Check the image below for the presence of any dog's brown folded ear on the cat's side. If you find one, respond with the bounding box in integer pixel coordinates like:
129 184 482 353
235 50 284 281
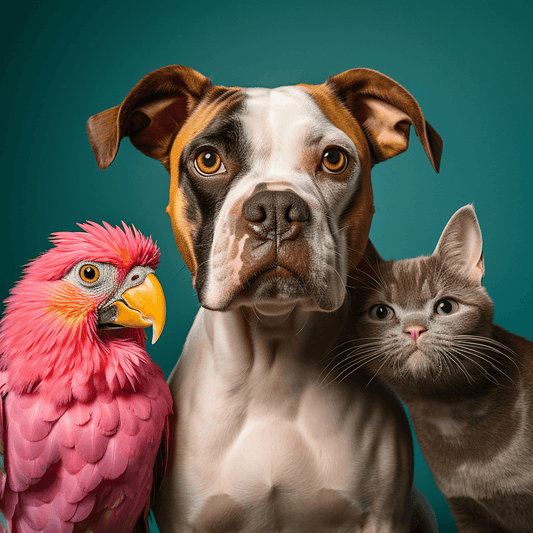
326 68 442 172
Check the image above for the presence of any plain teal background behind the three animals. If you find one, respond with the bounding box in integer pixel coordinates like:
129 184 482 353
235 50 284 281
0 0 533 533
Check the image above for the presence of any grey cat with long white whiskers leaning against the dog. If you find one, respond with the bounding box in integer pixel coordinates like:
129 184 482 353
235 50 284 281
340 205 533 533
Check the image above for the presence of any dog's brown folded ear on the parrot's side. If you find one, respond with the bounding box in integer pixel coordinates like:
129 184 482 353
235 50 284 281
87 65 212 170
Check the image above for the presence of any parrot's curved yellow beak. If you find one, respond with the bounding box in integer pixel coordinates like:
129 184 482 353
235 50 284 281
109 274 167 344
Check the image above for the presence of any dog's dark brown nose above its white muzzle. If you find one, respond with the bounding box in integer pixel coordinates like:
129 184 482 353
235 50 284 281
244 191 310 239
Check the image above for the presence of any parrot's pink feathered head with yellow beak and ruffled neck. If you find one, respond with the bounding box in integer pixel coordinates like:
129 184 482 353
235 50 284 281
0 222 166 400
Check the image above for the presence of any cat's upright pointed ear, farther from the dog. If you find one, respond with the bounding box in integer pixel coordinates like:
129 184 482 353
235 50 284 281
433 204 485 285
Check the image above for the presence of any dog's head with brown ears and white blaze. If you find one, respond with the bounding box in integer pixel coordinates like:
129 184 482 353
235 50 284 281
87 66 442 311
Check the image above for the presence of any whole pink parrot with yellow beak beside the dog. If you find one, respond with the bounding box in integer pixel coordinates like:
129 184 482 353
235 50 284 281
0 222 172 533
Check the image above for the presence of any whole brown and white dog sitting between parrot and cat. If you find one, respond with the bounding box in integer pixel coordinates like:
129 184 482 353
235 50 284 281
88 66 442 533
